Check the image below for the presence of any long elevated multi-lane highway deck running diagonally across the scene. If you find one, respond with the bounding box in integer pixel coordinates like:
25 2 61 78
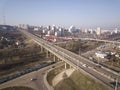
21 30 120 88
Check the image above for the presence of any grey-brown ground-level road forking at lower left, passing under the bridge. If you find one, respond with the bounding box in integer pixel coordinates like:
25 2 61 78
0 62 63 90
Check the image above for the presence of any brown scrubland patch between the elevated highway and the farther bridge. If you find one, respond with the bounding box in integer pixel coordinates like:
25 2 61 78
58 40 102 54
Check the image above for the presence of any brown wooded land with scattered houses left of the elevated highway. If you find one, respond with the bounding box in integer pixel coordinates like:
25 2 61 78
0 30 51 78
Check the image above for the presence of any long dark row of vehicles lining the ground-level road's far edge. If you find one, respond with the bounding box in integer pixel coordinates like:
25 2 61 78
0 61 54 84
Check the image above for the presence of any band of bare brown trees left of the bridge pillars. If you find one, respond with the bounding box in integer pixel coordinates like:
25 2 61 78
0 46 40 64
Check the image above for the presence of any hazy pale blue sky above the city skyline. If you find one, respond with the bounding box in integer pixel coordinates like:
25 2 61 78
0 0 120 28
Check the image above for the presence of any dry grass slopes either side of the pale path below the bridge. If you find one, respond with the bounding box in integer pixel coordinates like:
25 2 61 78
47 65 109 90
